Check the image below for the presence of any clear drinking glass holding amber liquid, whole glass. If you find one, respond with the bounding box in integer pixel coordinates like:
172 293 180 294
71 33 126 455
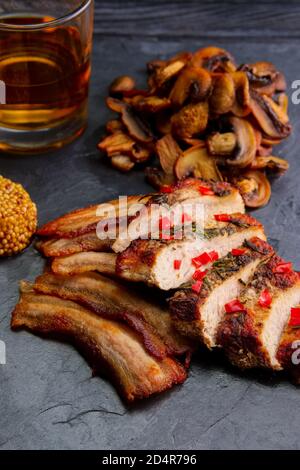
0 0 93 154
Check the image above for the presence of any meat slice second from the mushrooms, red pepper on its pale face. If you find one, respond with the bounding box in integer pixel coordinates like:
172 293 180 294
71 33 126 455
116 214 265 290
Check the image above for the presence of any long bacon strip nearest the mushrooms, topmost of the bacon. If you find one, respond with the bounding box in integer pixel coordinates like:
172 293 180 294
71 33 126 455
37 196 151 238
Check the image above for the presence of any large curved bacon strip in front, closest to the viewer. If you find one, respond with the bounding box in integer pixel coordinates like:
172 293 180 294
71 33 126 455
11 293 187 401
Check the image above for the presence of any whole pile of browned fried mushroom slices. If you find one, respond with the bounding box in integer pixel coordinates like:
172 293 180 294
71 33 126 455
98 47 291 208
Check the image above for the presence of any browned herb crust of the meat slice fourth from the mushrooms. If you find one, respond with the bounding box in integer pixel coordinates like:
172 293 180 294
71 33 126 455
218 255 298 369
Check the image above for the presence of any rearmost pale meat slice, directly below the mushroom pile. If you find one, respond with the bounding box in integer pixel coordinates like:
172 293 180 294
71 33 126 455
112 178 245 253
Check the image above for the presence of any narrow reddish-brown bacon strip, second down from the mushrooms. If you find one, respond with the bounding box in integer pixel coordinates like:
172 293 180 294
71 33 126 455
36 232 113 258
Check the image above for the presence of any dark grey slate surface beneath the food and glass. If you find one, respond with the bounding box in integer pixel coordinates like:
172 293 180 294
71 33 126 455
0 1 300 449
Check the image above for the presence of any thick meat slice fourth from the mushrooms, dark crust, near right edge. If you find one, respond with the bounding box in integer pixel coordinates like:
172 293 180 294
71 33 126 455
218 255 300 370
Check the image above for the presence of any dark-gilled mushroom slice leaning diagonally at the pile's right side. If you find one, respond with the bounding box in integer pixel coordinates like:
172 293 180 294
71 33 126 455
250 90 292 139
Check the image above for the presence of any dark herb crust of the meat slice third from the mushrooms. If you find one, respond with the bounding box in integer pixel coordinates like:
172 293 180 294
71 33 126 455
169 237 274 341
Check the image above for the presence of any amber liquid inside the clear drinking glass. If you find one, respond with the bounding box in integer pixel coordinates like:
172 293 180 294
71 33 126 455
0 16 90 143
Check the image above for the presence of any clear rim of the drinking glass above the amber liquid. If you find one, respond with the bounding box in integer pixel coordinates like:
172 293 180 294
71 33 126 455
0 0 93 31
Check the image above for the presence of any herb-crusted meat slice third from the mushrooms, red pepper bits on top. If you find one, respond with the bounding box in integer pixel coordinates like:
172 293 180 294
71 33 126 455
170 237 273 348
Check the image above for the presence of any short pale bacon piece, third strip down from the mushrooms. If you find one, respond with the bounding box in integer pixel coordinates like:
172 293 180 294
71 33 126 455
51 251 117 274
